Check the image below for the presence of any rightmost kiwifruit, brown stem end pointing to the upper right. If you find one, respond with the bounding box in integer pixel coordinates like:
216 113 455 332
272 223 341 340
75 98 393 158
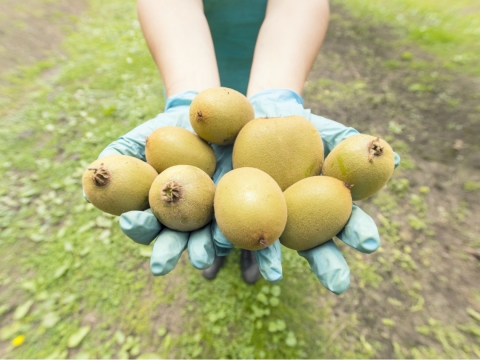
322 134 395 201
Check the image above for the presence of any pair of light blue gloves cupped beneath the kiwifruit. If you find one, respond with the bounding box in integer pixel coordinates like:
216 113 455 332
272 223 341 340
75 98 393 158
95 89 400 294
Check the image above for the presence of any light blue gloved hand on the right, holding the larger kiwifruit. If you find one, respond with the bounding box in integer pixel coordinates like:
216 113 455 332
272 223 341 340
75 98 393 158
213 89 400 294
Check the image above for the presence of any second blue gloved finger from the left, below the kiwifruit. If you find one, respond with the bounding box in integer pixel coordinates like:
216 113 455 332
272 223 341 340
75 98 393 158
150 228 190 276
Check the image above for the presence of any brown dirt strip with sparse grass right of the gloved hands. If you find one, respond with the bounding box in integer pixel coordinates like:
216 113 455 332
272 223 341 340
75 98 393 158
306 6 480 358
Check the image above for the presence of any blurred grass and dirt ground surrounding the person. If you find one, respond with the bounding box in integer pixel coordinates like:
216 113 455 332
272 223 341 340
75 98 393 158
0 0 480 358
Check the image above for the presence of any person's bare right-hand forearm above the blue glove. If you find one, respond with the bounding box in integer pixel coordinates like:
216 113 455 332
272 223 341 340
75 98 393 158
247 0 329 96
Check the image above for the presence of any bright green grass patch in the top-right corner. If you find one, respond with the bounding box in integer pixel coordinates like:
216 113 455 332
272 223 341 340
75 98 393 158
333 0 480 75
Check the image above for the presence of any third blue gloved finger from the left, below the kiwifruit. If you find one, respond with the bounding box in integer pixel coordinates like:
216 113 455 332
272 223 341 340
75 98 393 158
188 225 215 270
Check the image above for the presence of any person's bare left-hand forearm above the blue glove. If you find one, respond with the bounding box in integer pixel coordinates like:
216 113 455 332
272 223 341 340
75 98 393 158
137 0 220 96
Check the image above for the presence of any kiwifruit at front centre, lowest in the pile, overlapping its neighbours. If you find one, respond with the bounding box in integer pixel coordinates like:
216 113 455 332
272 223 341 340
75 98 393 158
215 167 287 250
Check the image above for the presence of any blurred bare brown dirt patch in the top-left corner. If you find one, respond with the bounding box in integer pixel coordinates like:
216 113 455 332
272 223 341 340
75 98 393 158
0 0 87 78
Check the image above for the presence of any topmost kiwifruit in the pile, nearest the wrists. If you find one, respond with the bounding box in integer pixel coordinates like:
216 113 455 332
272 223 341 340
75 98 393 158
190 87 255 145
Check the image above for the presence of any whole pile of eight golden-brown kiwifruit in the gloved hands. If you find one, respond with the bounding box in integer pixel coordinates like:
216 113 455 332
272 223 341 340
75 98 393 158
82 87 394 250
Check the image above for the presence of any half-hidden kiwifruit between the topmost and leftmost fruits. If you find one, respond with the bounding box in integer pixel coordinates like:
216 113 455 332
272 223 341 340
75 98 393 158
145 126 216 176
